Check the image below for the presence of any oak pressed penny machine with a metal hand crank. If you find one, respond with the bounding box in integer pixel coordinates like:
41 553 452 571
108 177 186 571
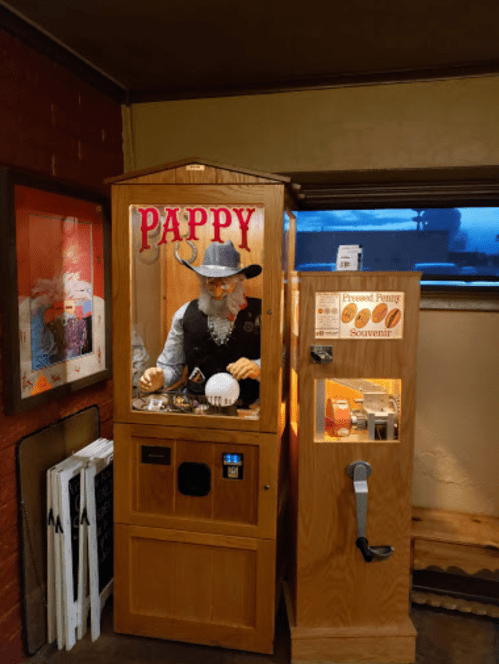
286 271 420 664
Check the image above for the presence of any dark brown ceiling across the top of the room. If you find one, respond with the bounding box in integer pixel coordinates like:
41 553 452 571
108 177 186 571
0 0 499 101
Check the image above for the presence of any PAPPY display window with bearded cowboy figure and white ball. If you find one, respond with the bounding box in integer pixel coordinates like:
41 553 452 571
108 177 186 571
129 205 264 419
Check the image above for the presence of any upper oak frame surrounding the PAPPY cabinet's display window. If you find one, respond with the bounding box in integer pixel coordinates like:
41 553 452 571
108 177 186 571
113 178 285 433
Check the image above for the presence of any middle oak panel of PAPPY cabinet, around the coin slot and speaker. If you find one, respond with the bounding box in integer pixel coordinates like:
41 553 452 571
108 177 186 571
114 425 280 539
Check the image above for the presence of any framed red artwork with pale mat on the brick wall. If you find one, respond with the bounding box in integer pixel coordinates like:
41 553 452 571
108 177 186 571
0 168 111 414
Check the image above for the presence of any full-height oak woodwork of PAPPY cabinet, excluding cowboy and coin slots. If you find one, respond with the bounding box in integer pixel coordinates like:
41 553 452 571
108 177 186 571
112 169 289 653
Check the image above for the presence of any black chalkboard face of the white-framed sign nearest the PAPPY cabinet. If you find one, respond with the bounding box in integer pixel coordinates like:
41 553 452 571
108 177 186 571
95 462 113 593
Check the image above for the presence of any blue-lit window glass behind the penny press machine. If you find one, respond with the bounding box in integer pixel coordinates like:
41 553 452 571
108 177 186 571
296 207 499 288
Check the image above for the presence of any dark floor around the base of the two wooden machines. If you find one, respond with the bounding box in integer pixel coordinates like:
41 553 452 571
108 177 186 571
26 603 499 664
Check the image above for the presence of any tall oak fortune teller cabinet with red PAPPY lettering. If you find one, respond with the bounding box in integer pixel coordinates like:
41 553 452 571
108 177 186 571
111 161 292 653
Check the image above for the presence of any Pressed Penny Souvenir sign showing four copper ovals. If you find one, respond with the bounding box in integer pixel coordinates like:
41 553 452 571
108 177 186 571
315 291 405 340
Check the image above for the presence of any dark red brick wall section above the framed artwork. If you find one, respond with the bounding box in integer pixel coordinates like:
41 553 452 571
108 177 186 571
0 26 123 189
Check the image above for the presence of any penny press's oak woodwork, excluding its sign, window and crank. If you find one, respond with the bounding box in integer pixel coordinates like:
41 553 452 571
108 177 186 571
289 273 419 662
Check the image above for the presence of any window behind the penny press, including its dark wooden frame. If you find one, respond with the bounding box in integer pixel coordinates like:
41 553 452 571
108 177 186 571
285 166 499 294
